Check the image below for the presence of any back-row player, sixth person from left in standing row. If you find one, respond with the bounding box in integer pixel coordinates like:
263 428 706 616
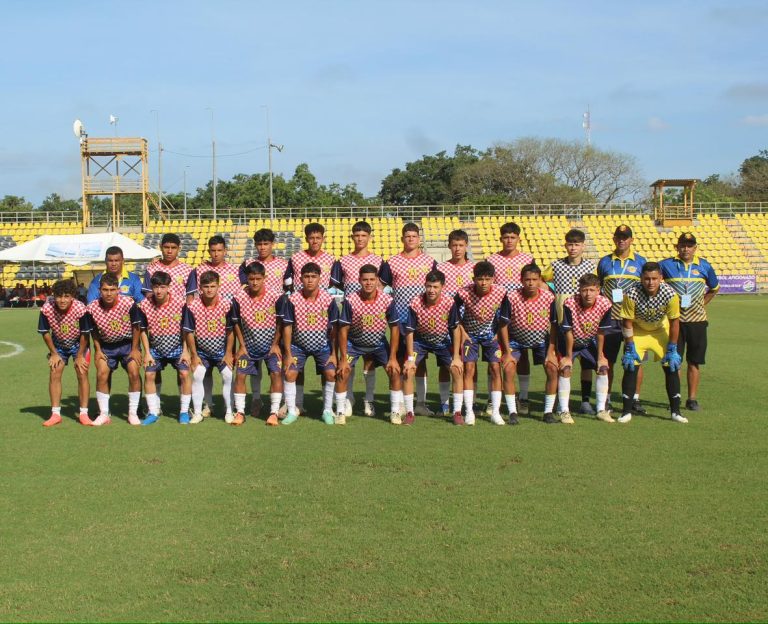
331 221 383 418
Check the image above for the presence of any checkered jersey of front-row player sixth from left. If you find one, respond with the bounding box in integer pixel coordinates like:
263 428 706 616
283 290 339 353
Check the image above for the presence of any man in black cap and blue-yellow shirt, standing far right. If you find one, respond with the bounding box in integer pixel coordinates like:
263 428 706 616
661 232 720 412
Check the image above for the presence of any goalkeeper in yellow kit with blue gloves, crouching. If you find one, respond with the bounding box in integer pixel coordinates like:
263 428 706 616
618 262 688 423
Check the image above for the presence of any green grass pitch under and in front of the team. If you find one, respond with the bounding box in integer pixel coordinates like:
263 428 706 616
0 297 768 621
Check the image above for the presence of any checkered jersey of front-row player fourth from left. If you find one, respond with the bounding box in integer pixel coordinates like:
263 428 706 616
181 296 237 361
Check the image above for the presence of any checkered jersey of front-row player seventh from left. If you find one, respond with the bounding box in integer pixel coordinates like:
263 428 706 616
339 290 400 348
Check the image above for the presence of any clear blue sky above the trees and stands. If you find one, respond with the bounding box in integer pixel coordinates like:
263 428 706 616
0 0 768 204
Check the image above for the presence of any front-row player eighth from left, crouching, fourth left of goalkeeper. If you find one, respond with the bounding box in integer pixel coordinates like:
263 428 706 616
400 269 462 425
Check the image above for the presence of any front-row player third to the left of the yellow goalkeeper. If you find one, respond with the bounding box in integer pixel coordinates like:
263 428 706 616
453 261 514 425
